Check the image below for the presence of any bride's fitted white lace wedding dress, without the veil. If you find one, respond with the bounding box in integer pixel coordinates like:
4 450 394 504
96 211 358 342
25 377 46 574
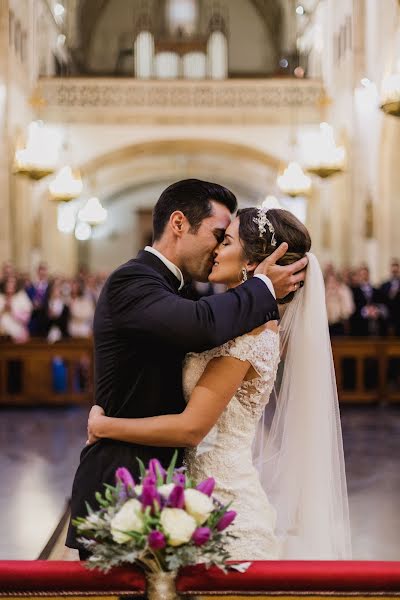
183 329 280 560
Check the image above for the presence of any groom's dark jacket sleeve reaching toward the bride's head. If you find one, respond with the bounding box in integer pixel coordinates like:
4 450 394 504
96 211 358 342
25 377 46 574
108 267 279 352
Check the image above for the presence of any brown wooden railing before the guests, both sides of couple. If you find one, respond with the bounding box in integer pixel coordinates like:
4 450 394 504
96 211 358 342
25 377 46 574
0 338 400 405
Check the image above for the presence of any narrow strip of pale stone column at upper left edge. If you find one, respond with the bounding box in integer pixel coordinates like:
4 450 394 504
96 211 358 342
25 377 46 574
0 0 14 262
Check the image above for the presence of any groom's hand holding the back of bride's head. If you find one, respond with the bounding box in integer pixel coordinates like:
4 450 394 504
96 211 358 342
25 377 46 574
254 242 308 298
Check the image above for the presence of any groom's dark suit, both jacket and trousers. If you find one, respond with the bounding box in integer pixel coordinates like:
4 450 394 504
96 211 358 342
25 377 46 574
67 251 279 548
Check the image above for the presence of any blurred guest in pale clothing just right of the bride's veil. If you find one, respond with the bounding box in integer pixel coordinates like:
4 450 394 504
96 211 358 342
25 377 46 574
325 271 355 336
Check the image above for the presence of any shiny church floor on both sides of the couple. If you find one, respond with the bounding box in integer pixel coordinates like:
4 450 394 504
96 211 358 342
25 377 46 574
0 406 400 560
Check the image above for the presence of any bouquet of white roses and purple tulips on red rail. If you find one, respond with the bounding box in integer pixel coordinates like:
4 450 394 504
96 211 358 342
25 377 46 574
74 453 236 574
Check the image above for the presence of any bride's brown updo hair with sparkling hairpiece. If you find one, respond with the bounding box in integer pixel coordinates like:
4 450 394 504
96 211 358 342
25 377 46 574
237 208 311 304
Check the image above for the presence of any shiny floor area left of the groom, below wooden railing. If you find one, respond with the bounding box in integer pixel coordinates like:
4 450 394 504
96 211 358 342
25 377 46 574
0 407 88 559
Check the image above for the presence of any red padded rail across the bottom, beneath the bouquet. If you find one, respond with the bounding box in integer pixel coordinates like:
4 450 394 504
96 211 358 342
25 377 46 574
0 561 400 597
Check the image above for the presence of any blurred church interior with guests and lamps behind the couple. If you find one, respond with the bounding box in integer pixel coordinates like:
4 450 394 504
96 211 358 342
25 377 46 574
0 0 400 595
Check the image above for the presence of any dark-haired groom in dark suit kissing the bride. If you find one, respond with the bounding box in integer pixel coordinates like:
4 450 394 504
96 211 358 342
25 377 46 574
66 179 307 558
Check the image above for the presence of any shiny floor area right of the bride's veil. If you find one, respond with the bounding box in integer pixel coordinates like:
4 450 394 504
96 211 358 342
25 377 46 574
341 405 400 560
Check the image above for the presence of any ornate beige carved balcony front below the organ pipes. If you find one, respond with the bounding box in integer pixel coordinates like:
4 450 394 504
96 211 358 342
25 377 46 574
40 78 325 124
